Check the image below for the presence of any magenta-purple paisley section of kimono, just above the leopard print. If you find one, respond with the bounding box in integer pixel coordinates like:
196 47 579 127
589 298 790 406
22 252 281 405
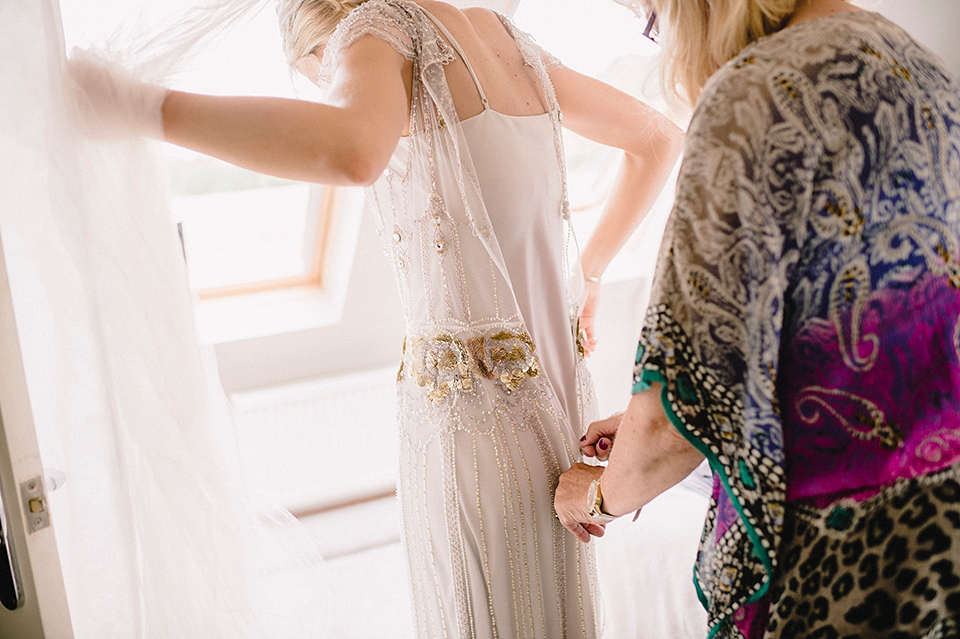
780 273 960 503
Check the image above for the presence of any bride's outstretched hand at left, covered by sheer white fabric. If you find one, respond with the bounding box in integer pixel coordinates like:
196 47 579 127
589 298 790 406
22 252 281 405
66 48 169 139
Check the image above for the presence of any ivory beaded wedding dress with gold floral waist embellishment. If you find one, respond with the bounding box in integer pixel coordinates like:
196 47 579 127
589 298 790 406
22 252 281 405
324 0 597 639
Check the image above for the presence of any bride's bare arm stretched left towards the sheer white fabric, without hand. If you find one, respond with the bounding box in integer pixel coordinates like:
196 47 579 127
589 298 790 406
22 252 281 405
163 36 410 185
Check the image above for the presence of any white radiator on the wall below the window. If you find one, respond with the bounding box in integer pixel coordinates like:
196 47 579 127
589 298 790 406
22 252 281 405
230 367 398 512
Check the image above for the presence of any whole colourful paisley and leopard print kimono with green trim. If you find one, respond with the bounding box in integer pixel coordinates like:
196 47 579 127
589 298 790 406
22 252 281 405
635 12 960 638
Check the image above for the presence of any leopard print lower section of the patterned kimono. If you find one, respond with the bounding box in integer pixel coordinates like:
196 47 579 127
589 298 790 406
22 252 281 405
766 467 960 639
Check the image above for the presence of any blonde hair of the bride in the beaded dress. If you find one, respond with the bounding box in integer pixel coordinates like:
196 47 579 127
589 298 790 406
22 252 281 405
277 0 367 65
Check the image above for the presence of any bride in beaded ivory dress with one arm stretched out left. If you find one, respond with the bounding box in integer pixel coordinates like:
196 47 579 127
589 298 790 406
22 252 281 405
71 0 681 638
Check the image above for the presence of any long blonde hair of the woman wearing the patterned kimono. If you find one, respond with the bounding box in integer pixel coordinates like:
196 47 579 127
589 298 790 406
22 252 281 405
653 0 803 104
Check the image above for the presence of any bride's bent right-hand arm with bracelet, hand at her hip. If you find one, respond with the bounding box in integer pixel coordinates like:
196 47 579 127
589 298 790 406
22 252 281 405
550 66 683 351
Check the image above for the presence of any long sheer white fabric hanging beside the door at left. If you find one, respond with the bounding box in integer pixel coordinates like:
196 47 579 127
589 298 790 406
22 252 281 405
0 0 330 639
